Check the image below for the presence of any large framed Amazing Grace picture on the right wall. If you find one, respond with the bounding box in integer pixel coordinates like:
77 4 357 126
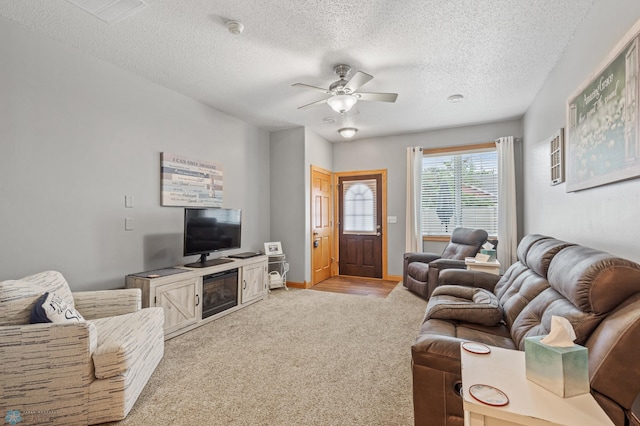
565 21 640 192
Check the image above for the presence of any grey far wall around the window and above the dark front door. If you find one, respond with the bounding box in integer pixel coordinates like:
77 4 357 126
333 120 522 275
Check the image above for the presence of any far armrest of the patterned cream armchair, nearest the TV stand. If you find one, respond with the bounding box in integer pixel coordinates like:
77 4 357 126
73 288 142 319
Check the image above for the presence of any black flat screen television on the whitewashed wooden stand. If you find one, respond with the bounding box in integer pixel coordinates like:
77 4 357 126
184 208 242 268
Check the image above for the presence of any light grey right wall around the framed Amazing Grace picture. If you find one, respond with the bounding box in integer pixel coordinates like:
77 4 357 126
524 0 640 261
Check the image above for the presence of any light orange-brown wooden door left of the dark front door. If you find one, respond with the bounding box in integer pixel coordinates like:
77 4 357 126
311 166 333 284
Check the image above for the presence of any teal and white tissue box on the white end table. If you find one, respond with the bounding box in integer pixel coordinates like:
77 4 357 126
524 336 590 398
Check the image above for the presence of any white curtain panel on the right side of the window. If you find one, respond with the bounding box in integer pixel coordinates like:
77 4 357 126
496 136 518 271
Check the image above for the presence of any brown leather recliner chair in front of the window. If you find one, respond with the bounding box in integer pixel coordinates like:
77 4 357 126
402 228 488 299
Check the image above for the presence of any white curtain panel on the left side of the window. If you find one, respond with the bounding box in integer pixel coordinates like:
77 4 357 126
405 147 422 252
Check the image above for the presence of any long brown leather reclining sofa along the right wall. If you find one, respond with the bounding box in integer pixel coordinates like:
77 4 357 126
411 235 640 426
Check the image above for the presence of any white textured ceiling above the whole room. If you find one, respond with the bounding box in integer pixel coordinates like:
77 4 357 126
0 0 605 141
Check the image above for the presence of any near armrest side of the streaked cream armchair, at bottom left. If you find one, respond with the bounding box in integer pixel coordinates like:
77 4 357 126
0 322 97 424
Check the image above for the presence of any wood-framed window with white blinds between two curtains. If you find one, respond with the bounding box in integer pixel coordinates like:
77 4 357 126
421 143 498 237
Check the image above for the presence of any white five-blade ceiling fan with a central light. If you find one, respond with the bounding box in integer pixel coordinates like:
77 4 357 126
293 64 398 113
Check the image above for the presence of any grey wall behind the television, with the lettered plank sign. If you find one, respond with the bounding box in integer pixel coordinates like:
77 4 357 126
0 19 269 290
